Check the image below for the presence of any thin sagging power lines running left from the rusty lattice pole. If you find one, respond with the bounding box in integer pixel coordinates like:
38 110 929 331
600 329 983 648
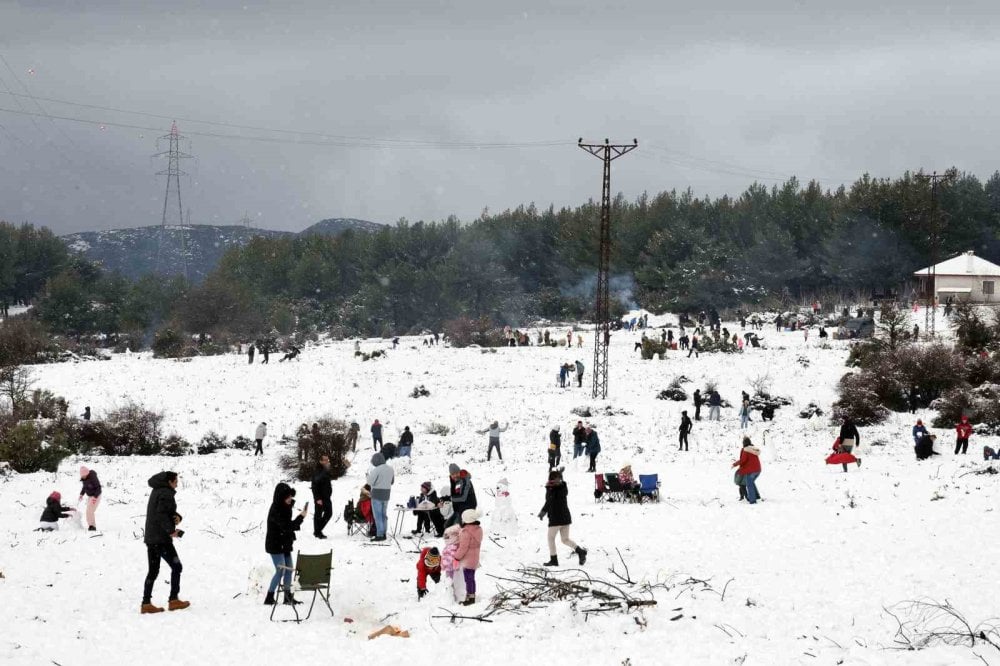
0 90 572 148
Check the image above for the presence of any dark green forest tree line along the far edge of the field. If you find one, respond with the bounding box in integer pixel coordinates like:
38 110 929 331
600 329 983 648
0 166 1000 343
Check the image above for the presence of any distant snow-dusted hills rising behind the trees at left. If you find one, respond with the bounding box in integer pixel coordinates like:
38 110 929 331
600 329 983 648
62 218 382 282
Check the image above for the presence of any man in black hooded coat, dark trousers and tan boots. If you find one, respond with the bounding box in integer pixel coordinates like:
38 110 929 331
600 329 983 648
139 472 191 614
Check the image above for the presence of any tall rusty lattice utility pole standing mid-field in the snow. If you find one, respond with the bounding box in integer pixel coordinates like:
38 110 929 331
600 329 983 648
577 139 639 399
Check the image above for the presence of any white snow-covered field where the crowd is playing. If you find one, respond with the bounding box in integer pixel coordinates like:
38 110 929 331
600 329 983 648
0 308 1000 666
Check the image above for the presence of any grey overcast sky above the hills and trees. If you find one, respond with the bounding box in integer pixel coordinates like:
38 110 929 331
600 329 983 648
0 0 1000 233
